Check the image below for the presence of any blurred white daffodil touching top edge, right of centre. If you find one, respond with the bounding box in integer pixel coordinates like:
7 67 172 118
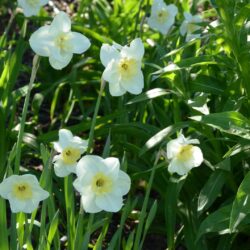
148 0 178 35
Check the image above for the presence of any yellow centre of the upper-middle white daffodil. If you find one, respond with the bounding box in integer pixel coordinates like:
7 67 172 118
119 57 138 78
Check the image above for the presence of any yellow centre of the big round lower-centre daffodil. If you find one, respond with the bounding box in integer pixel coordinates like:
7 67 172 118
91 173 113 195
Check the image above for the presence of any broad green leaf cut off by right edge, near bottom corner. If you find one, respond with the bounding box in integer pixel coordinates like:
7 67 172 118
230 172 250 232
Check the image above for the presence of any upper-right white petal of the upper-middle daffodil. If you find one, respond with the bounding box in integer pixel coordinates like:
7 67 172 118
121 38 144 61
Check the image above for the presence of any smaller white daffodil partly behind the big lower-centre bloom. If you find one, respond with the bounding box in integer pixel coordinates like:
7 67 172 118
53 129 88 177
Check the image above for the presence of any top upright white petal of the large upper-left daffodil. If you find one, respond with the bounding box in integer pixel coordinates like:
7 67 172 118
50 11 71 33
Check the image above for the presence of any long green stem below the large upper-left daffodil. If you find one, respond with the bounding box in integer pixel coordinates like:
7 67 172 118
14 55 39 174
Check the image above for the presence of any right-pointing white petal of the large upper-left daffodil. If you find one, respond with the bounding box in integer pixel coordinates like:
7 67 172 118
69 32 90 54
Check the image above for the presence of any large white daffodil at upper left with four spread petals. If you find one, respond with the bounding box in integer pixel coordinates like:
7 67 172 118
29 11 90 69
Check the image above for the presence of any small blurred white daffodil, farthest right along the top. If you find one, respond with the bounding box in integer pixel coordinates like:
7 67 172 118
180 12 202 42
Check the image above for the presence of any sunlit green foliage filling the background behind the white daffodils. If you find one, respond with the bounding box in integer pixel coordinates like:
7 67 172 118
0 0 250 250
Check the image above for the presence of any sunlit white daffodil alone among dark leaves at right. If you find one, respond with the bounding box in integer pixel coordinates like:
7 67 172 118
167 134 203 175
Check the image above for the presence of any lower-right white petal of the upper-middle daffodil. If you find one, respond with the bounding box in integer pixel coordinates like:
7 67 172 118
120 70 144 95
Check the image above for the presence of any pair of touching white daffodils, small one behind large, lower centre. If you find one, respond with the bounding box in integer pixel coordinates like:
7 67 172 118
54 129 130 213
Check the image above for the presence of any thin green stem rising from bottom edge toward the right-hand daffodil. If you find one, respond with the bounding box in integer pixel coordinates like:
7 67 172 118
133 153 160 250
